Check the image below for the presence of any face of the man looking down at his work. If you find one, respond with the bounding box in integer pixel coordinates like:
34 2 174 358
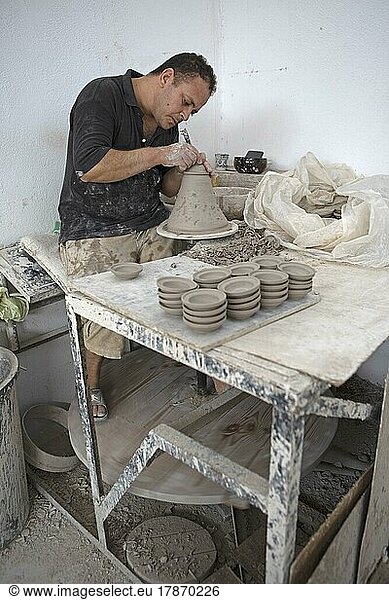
154 69 210 129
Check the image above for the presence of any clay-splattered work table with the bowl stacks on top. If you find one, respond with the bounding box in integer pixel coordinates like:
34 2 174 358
62 252 389 583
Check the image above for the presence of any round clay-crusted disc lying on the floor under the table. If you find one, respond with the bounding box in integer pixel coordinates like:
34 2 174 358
125 515 216 583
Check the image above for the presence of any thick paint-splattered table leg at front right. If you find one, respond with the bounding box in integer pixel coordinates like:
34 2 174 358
265 406 305 583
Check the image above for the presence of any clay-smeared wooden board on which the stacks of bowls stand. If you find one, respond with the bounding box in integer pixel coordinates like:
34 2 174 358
69 256 320 351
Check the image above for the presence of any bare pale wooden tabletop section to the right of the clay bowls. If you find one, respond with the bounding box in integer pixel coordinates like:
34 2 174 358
223 263 389 385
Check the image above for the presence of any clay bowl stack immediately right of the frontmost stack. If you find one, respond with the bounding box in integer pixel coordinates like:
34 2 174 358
217 271 261 320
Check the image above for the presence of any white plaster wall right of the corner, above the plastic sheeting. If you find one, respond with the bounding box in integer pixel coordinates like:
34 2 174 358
219 0 389 175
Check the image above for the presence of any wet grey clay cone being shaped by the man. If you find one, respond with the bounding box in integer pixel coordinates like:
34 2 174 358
165 165 230 235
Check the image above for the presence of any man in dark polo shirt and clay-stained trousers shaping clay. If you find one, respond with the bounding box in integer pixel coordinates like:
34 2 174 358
59 52 216 419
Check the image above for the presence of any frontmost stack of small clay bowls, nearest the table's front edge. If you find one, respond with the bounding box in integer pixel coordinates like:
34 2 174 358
181 288 227 333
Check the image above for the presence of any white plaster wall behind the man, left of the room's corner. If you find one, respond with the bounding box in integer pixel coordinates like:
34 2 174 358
0 0 220 245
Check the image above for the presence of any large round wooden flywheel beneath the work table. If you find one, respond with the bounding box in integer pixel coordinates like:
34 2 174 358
69 348 337 505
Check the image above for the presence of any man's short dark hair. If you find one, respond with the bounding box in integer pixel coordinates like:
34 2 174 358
149 52 216 96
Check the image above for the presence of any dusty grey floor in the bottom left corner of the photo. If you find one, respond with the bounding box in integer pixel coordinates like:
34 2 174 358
0 490 389 584
